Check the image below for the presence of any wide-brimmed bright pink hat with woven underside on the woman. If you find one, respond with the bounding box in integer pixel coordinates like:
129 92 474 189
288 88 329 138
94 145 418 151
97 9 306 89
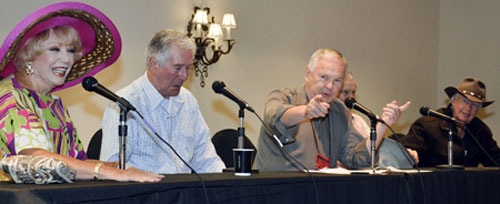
0 2 122 91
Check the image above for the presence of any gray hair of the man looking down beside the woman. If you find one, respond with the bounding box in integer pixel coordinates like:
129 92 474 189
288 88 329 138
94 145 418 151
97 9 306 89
146 29 196 69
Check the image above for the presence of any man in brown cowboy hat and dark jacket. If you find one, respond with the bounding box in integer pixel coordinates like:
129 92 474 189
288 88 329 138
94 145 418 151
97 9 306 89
402 77 500 167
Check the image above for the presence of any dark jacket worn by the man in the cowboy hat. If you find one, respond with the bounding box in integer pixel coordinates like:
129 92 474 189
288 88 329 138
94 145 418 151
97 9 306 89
401 105 500 167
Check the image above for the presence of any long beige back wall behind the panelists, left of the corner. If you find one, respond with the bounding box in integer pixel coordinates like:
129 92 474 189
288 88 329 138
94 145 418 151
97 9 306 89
0 0 498 151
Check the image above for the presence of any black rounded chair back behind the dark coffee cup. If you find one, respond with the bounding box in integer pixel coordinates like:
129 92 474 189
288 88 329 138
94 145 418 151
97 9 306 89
212 129 257 168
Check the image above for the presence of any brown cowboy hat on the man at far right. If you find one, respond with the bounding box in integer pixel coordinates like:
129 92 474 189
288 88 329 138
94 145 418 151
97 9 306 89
444 77 495 108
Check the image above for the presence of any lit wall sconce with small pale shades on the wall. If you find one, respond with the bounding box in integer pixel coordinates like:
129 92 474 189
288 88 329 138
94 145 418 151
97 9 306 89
187 7 237 87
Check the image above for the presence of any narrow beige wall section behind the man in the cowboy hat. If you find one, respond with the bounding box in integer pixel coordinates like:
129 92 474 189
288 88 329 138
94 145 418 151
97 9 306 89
436 0 500 141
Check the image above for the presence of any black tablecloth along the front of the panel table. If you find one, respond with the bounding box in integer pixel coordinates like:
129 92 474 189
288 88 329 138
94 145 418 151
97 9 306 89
0 169 500 204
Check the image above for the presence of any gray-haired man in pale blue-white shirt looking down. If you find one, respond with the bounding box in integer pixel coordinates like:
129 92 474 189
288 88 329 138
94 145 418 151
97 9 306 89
100 30 225 174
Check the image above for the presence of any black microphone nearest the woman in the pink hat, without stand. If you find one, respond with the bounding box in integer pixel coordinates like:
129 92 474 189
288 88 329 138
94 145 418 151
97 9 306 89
82 77 135 111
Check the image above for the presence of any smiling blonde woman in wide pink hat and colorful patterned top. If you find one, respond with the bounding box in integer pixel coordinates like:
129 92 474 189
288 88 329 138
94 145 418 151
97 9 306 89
0 2 163 182
